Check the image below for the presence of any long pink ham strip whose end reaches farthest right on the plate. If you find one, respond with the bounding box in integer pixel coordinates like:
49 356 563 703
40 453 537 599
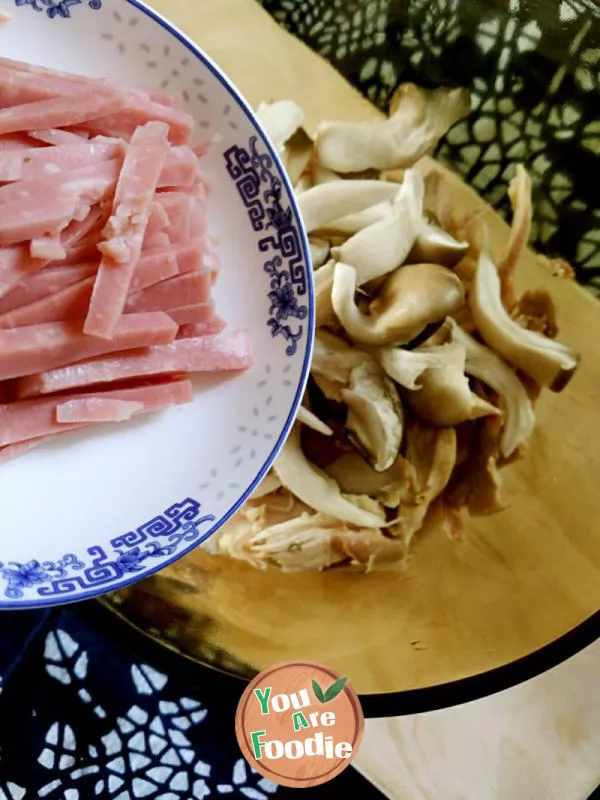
15 331 253 398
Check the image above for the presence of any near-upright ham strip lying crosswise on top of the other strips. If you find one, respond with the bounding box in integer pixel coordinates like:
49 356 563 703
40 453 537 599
84 122 168 338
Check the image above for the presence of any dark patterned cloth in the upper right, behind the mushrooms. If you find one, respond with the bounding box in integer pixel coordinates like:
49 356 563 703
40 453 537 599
259 0 600 296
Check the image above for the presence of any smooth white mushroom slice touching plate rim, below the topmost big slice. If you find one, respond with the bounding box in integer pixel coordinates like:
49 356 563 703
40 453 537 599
298 180 398 233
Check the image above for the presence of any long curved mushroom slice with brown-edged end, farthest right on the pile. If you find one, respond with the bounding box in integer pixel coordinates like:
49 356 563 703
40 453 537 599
468 251 579 392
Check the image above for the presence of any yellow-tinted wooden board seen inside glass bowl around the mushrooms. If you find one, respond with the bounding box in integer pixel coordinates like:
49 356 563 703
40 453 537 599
136 0 600 692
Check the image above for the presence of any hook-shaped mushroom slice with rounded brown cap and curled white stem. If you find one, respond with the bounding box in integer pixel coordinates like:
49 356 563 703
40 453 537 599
331 262 464 346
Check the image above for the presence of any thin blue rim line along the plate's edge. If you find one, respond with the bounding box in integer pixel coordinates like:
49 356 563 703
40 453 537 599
0 0 315 611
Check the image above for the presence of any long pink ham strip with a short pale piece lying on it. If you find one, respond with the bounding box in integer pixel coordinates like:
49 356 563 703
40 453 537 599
0 380 192 446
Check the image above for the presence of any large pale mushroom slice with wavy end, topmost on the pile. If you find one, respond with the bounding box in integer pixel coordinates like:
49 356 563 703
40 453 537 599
316 84 470 174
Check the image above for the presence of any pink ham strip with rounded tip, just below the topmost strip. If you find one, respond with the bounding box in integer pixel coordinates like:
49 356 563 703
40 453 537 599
0 89 127 133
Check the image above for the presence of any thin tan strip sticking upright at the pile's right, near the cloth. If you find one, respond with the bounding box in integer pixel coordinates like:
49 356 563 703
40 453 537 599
498 164 533 311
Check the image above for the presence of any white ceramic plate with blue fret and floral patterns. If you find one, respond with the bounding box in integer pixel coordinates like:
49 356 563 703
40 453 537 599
0 0 313 608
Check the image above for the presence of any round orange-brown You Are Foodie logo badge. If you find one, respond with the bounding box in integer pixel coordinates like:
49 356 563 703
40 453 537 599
235 661 365 789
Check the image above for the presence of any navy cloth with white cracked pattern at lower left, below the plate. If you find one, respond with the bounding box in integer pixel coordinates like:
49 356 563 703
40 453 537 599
0 603 383 800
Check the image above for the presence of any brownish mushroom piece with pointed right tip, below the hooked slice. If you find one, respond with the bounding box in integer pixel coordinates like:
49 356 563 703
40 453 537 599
404 343 500 426
